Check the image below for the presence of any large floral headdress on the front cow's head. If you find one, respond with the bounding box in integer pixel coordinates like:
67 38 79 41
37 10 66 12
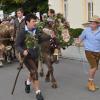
37 14 74 48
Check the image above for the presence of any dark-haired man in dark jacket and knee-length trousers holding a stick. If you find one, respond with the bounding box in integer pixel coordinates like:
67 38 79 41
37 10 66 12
16 14 44 100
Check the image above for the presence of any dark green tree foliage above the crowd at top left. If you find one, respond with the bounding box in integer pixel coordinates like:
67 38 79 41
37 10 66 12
0 0 48 13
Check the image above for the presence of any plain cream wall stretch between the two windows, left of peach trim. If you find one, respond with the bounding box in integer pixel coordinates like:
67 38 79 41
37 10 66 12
68 0 84 28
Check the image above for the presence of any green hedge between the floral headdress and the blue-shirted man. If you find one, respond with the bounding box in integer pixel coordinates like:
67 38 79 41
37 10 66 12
69 28 83 38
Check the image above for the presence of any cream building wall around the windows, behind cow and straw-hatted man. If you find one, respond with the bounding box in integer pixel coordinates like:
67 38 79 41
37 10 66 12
49 0 100 28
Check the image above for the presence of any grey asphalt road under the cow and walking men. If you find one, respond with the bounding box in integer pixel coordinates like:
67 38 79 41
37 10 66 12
0 59 100 100
